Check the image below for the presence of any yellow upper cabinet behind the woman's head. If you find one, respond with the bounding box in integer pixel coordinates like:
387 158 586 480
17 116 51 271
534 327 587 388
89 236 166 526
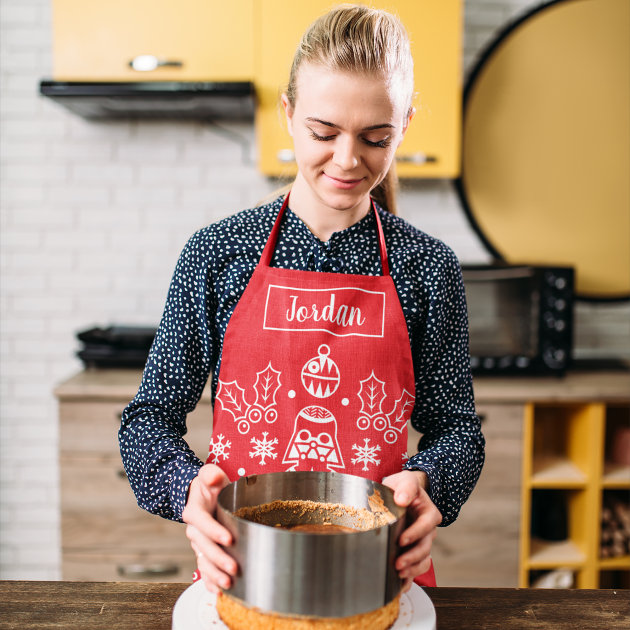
255 0 463 178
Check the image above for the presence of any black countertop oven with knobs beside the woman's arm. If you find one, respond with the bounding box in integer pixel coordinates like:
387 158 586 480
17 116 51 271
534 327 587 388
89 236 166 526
462 265 574 374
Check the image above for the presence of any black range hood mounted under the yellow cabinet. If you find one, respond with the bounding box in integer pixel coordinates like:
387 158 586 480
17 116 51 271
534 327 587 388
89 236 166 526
39 80 255 120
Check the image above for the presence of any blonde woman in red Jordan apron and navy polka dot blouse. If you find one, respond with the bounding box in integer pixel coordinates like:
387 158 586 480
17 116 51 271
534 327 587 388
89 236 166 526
120 5 484 592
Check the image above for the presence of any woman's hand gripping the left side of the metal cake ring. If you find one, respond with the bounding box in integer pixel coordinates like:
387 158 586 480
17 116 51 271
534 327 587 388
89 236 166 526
182 464 238 593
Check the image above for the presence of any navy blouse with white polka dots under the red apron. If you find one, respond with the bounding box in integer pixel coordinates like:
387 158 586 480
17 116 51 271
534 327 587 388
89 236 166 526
119 198 484 525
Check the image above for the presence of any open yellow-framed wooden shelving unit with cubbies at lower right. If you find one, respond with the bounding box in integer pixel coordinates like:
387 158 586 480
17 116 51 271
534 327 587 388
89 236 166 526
519 397 630 588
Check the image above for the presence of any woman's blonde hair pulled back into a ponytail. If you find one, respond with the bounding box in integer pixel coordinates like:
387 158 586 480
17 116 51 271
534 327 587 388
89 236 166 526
286 4 413 214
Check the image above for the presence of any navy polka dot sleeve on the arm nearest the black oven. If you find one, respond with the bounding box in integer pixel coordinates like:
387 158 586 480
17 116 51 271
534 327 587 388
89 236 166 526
405 247 485 526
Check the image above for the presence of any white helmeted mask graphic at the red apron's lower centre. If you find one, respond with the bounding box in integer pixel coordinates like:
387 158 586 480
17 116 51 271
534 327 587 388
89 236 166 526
282 405 345 471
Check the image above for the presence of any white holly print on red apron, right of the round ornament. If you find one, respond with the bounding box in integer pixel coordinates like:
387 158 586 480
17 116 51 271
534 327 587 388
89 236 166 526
357 371 415 444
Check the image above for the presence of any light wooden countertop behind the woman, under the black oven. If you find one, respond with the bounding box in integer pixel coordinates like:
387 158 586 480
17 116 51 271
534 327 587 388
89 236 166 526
55 369 630 404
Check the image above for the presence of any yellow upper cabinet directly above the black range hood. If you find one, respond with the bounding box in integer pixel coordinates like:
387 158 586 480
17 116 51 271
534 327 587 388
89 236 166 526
52 0 254 81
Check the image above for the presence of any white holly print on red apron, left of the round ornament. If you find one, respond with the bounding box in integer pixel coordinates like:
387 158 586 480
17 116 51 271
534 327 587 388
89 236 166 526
216 362 280 435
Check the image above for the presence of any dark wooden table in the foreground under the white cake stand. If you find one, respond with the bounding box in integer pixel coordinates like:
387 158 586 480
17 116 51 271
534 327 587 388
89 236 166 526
0 581 630 630
